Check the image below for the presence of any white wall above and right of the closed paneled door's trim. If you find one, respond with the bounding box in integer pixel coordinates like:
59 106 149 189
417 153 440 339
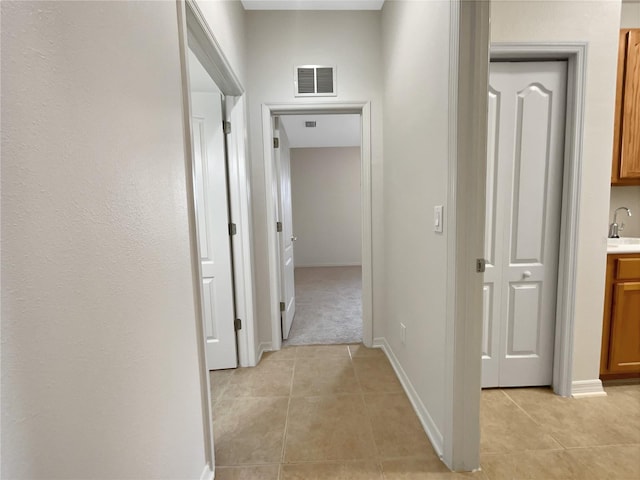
491 0 620 381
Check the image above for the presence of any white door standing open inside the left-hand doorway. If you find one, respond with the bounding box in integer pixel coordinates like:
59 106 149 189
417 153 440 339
189 50 238 370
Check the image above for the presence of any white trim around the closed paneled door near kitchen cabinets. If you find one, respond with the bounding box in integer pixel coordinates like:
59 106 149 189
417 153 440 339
491 42 587 397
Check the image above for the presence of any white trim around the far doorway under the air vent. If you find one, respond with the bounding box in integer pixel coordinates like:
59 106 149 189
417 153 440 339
262 102 373 350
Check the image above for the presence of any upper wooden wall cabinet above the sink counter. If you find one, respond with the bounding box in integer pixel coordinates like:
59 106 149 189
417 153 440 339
611 28 640 185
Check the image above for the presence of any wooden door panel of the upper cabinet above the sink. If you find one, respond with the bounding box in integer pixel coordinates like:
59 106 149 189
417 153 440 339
620 29 640 179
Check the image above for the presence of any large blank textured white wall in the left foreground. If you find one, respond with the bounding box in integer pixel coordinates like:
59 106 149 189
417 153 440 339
1 2 216 479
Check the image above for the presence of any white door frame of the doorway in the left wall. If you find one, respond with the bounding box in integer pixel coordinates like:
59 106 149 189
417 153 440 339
176 0 256 472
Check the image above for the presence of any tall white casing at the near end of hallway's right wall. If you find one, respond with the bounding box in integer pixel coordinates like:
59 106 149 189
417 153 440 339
442 0 490 471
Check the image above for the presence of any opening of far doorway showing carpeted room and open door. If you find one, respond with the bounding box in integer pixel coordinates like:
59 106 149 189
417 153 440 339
274 114 362 346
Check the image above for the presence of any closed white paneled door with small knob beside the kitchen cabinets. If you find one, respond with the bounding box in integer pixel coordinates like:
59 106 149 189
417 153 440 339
482 61 567 388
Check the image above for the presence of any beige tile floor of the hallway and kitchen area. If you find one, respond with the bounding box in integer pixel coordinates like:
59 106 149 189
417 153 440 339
211 345 640 480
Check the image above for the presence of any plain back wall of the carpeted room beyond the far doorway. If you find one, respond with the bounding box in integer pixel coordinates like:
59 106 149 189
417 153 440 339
291 147 362 267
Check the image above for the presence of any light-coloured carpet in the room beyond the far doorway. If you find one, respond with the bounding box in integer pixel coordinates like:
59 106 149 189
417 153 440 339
284 267 362 345
